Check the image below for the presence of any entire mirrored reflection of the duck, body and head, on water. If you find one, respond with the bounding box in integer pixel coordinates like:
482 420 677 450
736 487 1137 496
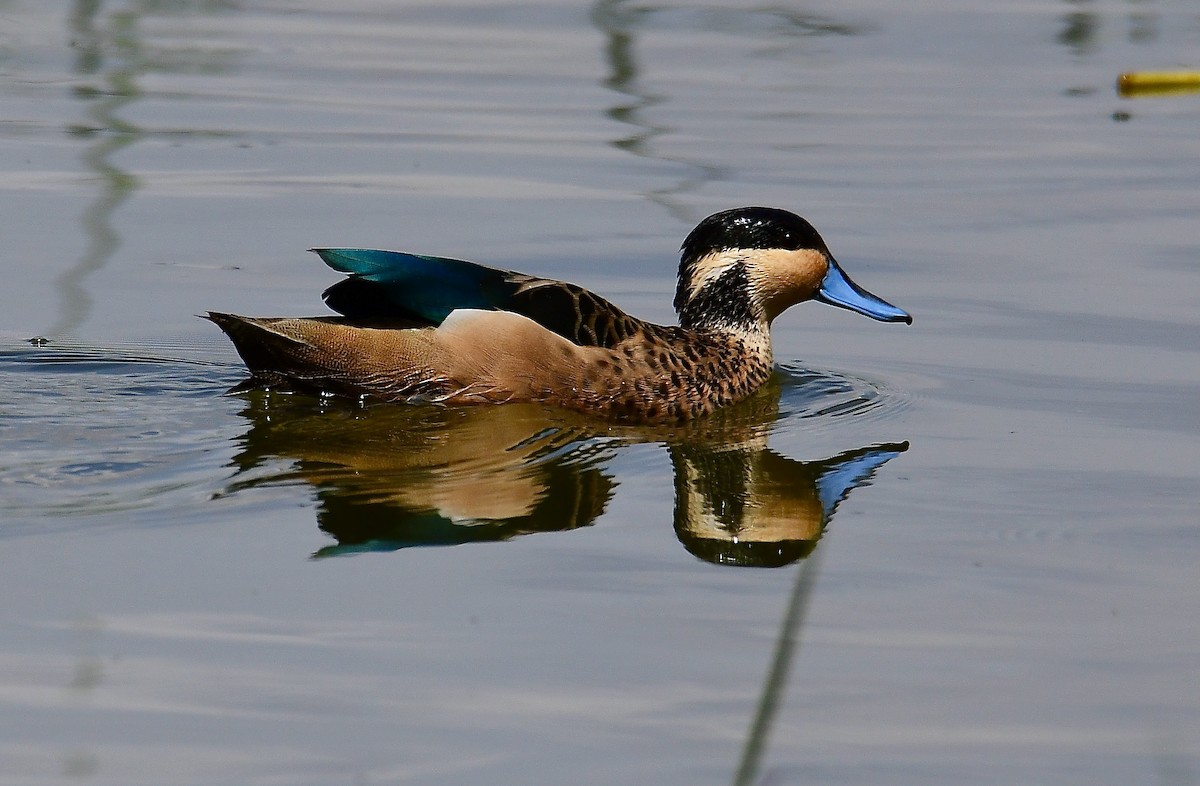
230 384 907 566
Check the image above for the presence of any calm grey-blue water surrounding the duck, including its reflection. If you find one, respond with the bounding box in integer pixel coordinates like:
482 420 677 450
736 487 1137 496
0 0 1200 785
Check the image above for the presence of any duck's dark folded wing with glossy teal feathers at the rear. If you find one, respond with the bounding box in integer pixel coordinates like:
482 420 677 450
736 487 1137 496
313 248 641 347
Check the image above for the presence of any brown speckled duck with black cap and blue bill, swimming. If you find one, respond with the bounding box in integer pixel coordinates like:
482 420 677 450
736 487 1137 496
208 208 912 421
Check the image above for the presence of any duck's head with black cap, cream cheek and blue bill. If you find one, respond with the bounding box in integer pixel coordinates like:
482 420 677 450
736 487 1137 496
674 208 912 329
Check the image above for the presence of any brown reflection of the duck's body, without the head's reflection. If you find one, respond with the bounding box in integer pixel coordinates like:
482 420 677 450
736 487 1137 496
234 400 614 557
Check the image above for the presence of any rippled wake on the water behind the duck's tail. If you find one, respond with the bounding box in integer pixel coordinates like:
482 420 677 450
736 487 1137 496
0 346 239 534
